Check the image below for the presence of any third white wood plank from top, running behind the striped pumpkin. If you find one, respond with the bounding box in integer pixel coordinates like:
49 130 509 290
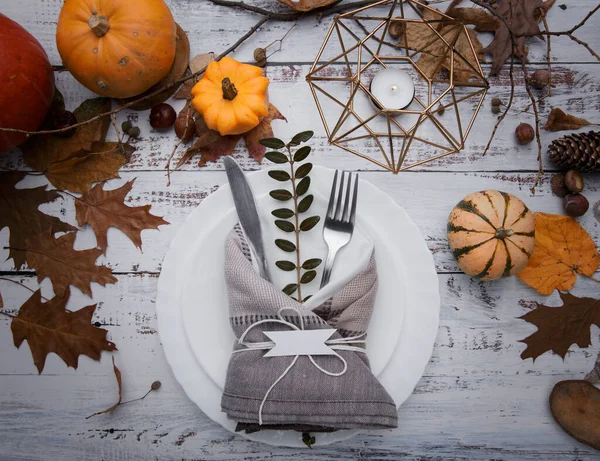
0 171 600 272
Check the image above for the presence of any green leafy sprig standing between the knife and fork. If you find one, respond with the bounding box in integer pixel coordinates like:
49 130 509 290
259 131 322 302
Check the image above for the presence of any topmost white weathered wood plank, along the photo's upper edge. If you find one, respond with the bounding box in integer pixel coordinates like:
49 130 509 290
2 0 600 64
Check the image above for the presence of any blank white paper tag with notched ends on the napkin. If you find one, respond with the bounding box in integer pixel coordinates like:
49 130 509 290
263 329 336 357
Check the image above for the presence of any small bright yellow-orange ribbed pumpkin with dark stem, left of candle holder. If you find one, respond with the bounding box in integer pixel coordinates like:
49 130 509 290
192 56 269 136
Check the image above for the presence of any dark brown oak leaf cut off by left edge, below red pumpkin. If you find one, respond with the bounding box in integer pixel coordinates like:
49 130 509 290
0 172 76 270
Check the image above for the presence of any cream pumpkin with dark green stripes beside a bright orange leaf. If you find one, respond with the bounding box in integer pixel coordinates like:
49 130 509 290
448 190 535 280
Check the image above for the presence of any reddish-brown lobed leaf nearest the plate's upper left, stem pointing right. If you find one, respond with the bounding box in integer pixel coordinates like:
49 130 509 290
75 179 169 253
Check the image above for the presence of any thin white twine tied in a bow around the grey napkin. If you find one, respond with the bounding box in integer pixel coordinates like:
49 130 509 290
233 306 366 426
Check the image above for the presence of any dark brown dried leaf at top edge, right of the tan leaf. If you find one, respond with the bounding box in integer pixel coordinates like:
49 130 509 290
483 0 555 76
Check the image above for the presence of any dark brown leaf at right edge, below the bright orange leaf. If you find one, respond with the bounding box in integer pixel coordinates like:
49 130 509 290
520 292 600 361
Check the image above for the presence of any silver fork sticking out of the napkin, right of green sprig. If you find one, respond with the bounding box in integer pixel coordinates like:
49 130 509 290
321 170 358 288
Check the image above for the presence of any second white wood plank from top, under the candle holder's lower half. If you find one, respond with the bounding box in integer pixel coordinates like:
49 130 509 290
0 64 600 171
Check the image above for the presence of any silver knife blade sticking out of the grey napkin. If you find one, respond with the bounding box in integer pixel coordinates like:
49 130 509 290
223 157 271 280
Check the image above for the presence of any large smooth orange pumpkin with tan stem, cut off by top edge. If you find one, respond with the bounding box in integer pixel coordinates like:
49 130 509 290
56 0 176 98
